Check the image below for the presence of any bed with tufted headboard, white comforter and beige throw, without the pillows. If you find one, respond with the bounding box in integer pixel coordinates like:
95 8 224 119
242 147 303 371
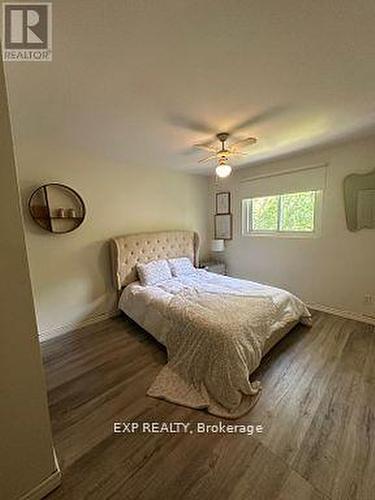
110 231 311 418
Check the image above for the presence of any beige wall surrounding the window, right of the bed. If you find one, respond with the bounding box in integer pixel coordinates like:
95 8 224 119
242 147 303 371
210 137 375 317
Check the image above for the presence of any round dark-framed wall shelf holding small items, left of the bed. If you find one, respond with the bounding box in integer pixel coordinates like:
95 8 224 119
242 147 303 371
29 182 86 234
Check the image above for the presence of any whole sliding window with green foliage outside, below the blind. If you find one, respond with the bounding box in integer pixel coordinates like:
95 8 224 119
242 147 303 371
243 191 321 236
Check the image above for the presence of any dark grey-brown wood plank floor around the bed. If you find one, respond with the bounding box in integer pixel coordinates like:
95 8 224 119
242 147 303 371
42 313 375 500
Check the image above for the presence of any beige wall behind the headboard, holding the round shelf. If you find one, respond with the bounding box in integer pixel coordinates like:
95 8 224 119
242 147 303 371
14 152 208 334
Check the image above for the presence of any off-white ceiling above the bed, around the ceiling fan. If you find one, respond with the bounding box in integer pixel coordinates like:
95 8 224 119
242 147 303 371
7 0 375 172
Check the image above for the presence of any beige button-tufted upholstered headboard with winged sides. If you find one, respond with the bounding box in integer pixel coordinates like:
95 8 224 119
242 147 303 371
110 231 199 290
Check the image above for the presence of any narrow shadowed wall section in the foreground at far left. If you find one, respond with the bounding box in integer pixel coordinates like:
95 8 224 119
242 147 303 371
0 57 55 500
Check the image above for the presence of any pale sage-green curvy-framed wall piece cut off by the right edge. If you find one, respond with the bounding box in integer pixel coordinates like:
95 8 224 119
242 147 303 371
344 170 375 231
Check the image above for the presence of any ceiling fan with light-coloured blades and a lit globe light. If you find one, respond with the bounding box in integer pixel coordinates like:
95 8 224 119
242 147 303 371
194 132 257 177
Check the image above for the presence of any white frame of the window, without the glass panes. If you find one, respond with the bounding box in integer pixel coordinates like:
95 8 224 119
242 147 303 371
242 189 323 238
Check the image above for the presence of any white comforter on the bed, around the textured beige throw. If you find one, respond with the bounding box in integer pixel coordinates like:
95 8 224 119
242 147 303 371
119 269 308 354
